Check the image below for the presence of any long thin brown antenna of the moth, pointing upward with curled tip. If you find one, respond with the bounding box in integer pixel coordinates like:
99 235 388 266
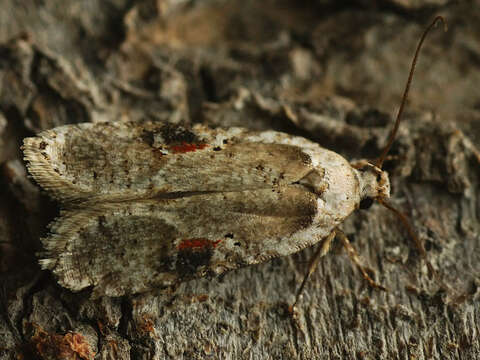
375 15 447 169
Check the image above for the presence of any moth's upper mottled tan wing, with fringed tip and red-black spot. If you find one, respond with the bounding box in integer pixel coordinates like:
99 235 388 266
24 122 312 206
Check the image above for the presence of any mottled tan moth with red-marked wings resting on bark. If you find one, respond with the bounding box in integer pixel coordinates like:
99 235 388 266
23 18 443 298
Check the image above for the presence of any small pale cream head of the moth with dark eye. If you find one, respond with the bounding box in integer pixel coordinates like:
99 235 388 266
352 160 390 209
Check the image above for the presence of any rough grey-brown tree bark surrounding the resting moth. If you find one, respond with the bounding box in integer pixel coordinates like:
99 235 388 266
0 0 480 359
